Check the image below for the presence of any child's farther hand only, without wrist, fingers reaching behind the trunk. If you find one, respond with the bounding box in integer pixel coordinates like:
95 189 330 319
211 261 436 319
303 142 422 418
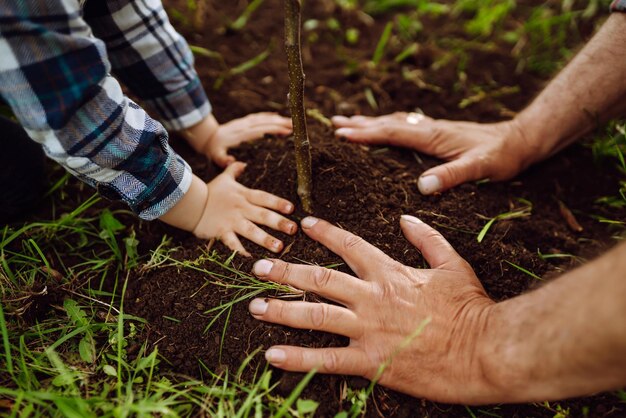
202 113 293 167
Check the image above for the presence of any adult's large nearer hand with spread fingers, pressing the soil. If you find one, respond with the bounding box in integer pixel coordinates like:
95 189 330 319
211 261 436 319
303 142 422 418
249 216 495 404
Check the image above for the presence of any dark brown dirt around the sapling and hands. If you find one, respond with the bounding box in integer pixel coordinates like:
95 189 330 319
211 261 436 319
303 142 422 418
126 0 626 417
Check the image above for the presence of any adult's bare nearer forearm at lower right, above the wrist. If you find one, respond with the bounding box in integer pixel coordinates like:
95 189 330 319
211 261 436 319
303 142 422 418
483 244 626 402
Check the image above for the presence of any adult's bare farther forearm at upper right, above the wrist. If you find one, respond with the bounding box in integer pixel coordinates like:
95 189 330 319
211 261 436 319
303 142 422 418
514 13 626 163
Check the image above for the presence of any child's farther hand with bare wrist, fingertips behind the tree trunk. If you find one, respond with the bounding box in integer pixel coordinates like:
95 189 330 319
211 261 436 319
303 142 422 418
183 113 293 167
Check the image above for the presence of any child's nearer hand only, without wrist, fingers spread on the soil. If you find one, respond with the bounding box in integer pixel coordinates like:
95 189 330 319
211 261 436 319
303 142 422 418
193 163 298 256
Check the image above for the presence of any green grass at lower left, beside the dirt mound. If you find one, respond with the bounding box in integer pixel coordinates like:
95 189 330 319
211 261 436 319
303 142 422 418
0 181 317 417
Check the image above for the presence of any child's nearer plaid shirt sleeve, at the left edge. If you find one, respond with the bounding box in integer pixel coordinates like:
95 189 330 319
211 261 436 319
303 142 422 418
0 0 208 220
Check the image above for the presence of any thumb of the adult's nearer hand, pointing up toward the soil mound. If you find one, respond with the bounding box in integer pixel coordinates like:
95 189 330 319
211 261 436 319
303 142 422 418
400 215 464 269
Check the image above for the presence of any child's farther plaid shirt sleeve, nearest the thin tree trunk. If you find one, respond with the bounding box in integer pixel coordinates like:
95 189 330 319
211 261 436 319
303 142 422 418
84 0 211 130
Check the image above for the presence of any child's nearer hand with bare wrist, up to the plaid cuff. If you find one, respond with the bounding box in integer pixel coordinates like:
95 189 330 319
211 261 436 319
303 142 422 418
160 163 297 256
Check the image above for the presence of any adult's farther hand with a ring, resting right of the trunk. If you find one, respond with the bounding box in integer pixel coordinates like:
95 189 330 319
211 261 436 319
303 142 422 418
333 112 539 195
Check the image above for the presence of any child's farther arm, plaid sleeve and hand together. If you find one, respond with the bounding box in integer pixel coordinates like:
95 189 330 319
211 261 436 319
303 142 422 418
84 0 292 167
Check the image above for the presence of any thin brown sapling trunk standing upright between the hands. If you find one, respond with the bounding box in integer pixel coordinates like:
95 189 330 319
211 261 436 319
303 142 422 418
285 0 313 213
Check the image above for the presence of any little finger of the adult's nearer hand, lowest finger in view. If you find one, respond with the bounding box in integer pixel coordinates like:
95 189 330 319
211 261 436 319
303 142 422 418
265 346 368 376
